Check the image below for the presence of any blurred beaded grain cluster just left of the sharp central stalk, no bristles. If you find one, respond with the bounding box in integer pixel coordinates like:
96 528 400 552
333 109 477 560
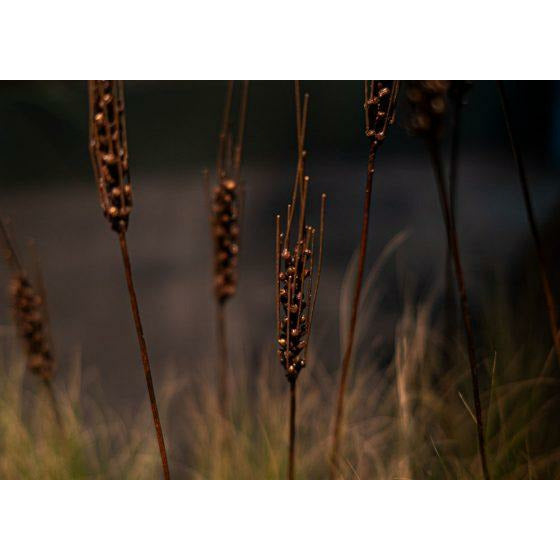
212 178 239 302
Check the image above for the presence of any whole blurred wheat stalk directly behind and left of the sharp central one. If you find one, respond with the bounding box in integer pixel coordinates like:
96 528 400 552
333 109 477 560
204 81 249 415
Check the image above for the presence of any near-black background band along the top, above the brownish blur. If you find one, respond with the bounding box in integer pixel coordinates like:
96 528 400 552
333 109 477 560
0 81 560 187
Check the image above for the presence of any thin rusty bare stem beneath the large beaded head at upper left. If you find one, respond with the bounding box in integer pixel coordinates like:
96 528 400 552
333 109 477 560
119 230 171 480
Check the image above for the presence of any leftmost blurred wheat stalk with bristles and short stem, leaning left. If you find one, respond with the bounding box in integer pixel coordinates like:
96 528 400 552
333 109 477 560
0 220 63 430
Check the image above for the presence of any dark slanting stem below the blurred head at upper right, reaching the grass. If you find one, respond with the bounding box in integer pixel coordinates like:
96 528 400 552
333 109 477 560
427 140 490 480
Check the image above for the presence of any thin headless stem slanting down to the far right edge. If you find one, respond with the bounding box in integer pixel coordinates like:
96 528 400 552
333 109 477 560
497 80 560 366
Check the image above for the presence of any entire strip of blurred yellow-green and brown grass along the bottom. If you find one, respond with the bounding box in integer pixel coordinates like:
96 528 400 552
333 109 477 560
0 235 560 479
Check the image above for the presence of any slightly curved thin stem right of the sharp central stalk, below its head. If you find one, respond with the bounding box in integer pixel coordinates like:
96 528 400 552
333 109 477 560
330 139 377 478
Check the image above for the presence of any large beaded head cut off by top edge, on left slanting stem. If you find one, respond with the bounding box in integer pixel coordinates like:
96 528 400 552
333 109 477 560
91 80 132 231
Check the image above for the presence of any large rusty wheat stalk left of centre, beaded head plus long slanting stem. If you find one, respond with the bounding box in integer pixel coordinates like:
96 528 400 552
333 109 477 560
88 80 170 479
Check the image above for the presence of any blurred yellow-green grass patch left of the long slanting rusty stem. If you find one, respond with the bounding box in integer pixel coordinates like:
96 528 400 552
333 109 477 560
0 334 158 479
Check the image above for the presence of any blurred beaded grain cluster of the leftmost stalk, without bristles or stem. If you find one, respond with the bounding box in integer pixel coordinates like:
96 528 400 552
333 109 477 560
10 275 54 379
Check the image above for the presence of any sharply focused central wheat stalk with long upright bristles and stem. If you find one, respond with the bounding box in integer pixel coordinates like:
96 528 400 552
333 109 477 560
275 82 327 480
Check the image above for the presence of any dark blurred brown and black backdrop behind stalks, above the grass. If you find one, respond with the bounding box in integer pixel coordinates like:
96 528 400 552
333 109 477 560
0 81 560 407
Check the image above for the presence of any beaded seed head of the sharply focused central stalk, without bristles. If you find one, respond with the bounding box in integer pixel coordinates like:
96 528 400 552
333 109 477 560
278 241 311 381
